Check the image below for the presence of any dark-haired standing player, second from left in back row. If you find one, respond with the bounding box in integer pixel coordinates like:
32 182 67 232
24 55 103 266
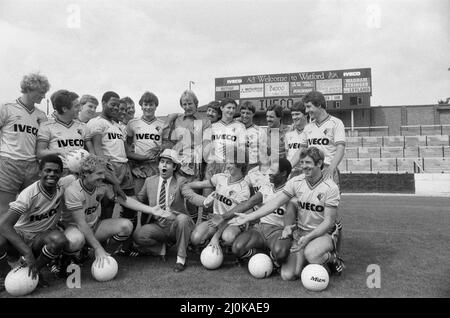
36 90 87 168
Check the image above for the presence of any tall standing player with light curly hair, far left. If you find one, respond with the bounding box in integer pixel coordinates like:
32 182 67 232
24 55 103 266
0 74 50 215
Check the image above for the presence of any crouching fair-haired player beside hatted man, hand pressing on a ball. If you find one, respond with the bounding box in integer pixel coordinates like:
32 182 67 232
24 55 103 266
60 155 167 276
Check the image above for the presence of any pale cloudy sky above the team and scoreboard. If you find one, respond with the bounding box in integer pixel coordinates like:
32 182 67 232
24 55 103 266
0 0 450 116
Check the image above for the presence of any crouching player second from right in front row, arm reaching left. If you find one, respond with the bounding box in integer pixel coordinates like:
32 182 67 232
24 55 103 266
229 158 295 267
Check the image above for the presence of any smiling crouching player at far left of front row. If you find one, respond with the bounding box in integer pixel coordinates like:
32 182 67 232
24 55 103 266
0 155 75 286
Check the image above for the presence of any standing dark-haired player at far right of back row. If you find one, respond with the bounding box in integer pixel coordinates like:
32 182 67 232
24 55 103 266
292 91 345 186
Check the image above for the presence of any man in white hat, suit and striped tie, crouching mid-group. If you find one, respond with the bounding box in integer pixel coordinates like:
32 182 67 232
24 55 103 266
128 149 195 272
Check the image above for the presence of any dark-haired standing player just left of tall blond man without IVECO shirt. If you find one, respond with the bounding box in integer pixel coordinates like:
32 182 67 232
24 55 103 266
127 92 164 193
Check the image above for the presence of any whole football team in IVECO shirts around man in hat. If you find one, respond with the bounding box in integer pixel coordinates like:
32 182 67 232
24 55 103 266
0 73 345 290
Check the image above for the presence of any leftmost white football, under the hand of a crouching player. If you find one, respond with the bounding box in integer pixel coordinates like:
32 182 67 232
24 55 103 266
5 267 39 296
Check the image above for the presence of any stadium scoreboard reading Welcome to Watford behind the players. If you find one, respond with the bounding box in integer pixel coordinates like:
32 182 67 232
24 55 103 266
215 68 372 112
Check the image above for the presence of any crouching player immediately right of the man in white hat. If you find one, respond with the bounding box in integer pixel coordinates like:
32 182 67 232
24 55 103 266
183 155 250 255
